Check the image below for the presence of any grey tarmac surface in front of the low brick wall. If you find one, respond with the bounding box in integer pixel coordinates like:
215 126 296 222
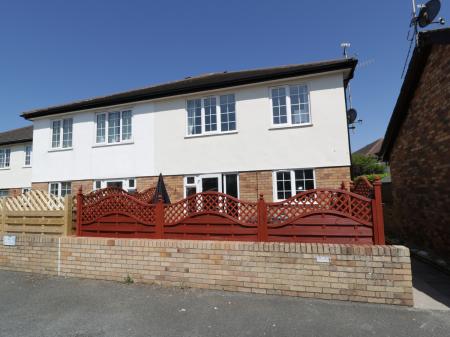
0 271 450 337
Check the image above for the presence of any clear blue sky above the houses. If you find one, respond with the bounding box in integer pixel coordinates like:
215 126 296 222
0 0 450 149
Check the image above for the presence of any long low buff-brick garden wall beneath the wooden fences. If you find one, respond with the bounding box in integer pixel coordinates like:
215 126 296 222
0 235 413 305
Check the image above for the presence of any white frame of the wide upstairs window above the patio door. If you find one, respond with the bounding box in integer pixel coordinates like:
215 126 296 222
185 92 238 138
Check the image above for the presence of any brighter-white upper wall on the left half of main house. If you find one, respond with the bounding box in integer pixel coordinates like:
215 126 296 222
32 104 155 182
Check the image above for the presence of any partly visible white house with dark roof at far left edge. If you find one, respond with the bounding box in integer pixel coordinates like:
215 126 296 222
0 126 33 197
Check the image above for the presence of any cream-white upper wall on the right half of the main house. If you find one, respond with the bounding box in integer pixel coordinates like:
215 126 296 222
155 73 350 175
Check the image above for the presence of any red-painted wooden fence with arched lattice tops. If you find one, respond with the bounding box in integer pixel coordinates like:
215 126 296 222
77 181 384 244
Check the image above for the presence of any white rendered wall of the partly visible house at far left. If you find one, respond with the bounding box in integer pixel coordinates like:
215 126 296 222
0 143 33 189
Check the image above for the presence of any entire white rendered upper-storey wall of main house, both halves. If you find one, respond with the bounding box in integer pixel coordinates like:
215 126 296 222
32 72 350 182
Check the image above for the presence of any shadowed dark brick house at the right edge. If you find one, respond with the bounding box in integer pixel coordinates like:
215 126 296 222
381 28 450 257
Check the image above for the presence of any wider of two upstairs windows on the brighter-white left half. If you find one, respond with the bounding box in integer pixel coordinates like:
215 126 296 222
95 110 132 144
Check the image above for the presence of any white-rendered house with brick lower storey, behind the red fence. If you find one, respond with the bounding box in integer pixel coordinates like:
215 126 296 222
22 59 357 201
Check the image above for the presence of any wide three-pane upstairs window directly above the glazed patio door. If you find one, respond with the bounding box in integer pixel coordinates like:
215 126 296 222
187 94 236 135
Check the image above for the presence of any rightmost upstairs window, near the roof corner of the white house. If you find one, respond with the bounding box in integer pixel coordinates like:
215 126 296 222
270 84 311 126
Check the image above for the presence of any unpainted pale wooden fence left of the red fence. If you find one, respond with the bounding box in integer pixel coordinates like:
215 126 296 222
0 190 72 235
